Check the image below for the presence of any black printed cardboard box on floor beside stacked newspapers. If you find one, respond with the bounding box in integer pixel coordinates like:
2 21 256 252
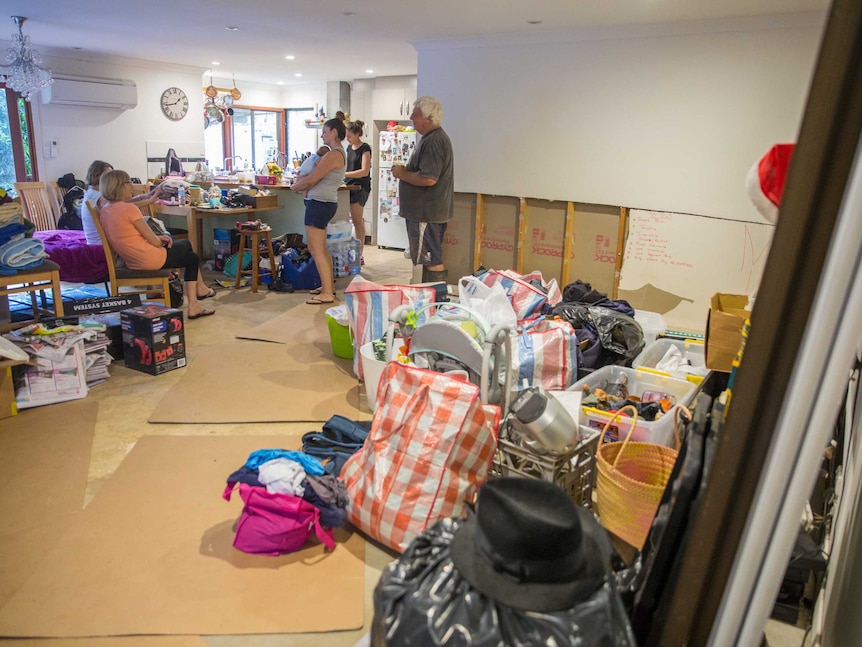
120 305 186 375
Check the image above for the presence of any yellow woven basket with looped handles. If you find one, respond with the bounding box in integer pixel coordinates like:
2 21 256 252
596 405 679 550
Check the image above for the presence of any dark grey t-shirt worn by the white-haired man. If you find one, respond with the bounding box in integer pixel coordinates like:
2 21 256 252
398 128 455 222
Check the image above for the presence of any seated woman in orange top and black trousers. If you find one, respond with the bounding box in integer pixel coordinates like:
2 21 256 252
99 171 215 319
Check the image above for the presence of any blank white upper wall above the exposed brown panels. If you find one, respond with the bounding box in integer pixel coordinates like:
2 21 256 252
418 14 824 222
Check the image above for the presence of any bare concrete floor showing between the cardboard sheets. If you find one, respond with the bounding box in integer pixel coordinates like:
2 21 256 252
59 246 804 647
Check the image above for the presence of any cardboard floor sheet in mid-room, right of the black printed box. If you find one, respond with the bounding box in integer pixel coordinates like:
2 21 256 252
149 340 359 423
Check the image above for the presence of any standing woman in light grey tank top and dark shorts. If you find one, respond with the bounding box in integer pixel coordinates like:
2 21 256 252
291 119 347 305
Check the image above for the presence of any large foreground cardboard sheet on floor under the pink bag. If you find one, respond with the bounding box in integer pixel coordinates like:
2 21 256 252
0 436 365 637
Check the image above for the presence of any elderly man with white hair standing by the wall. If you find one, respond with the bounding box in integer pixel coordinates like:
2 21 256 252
392 96 454 283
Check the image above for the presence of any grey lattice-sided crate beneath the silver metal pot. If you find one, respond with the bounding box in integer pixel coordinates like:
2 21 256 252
491 433 599 507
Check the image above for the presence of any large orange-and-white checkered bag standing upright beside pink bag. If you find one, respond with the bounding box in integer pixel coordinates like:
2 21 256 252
341 362 500 552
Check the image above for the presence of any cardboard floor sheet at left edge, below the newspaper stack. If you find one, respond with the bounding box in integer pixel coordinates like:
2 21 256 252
0 400 98 607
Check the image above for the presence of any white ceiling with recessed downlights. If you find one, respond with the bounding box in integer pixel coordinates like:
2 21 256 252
0 0 829 85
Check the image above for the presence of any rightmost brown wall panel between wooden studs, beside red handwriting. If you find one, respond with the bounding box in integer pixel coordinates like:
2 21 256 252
560 202 620 296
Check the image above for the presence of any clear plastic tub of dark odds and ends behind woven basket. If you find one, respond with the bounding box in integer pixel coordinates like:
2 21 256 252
569 365 697 447
